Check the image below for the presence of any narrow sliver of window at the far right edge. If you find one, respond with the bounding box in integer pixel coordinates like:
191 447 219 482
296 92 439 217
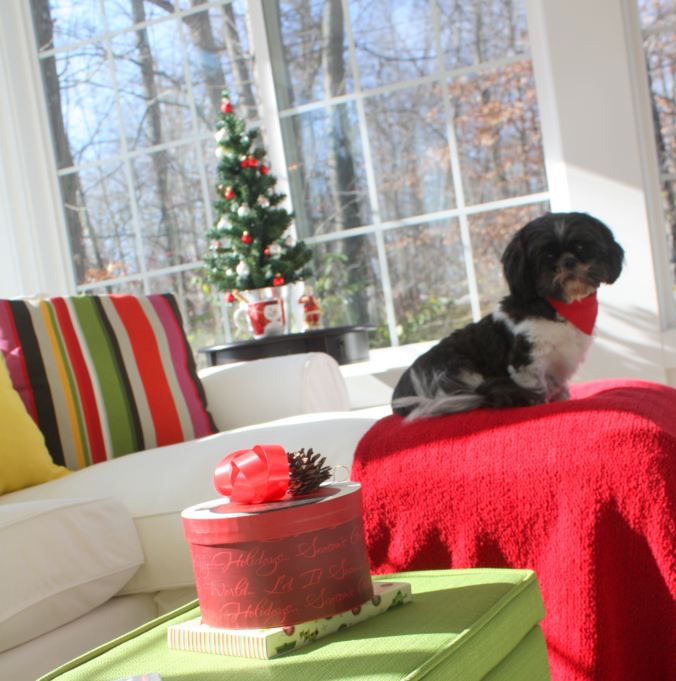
638 0 676 291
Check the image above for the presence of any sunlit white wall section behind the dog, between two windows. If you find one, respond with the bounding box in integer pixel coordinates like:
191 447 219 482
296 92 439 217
526 0 673 381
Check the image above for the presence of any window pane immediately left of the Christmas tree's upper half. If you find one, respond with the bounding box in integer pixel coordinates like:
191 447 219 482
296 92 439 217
133 145 206 270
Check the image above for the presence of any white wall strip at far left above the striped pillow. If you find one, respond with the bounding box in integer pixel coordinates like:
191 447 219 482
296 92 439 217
0 0 74 297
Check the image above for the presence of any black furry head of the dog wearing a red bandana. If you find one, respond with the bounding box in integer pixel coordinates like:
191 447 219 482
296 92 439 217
502 213 624 303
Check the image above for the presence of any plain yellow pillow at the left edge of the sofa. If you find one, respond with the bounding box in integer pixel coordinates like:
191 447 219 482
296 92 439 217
0 352 70 494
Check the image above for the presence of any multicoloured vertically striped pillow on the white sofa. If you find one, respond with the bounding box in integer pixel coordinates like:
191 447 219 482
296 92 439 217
0 294 216 470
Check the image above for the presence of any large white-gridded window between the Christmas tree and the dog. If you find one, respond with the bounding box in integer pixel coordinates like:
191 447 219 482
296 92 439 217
264 0 548 344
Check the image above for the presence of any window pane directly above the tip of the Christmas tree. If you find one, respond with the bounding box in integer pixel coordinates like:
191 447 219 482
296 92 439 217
184 1 258 131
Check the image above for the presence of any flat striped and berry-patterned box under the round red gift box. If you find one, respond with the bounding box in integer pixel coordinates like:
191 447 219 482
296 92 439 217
167 581 413 660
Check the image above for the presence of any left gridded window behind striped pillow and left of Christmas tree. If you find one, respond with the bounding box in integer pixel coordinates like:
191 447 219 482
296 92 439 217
31 0 257 344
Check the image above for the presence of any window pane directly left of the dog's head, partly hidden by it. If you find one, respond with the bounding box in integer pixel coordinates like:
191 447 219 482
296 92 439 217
469 198 549 315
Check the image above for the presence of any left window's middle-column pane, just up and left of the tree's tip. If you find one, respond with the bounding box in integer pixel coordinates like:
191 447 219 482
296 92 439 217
112 21 192 150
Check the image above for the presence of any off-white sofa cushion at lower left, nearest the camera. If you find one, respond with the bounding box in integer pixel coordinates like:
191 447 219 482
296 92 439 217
0 496 143 651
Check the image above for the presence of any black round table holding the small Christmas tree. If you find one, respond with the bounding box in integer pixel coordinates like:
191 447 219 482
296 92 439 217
199 326 374 366
